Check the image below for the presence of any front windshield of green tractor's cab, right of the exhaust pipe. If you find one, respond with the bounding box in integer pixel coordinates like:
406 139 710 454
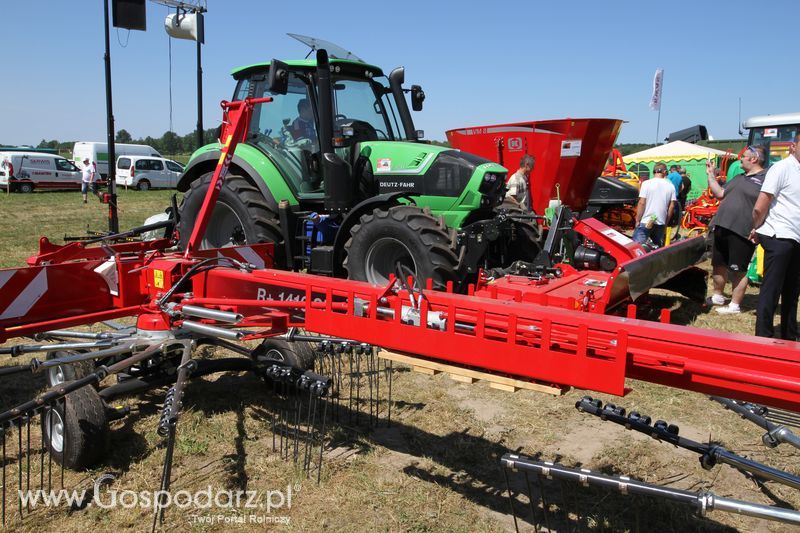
333 78 401 141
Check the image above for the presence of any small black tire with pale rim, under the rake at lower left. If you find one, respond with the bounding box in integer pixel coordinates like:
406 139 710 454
41 387 108 470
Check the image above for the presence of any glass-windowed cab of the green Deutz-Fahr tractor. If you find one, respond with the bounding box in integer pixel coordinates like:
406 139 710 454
221 53 417 202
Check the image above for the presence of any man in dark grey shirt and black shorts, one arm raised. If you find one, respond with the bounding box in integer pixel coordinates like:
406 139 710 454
706 145 767 315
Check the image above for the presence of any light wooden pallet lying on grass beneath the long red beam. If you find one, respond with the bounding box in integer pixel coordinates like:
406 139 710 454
378 350 569 396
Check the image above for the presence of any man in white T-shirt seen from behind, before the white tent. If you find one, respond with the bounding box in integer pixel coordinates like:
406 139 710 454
633 163 676 247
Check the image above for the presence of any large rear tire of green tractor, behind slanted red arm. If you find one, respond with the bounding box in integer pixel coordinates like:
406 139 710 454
178 172 285 268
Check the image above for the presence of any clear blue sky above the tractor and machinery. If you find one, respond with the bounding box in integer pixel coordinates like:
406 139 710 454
0 0 800 145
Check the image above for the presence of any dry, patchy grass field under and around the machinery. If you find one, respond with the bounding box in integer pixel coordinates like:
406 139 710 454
0 191 800 532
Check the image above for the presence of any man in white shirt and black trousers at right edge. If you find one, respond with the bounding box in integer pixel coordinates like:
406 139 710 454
750 134 800 341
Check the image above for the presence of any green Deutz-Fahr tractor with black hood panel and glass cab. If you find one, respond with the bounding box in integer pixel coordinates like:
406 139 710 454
178 40 540 288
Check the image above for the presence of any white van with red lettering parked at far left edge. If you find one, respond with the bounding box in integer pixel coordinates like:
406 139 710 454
0 152 87 193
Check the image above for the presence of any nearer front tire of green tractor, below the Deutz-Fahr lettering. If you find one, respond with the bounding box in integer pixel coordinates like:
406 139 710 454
343 205 458 290
